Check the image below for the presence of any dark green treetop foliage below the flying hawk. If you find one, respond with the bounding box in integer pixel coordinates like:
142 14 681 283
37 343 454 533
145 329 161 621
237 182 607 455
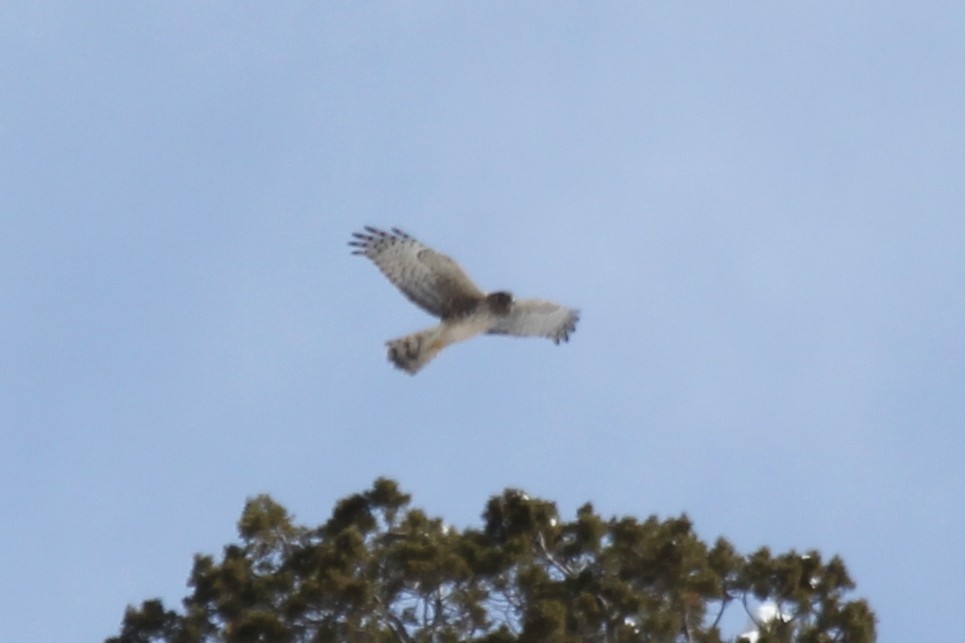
107 479 875 643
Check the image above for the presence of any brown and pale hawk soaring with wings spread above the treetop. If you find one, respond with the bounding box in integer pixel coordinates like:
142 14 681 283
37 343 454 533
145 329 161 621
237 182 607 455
349 226 580 375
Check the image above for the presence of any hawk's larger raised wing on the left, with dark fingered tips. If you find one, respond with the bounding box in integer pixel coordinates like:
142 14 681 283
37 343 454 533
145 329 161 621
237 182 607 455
349 226 485 318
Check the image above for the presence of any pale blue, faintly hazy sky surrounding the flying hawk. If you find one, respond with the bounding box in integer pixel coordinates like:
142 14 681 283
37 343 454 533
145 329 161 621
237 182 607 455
0 1 965 642
